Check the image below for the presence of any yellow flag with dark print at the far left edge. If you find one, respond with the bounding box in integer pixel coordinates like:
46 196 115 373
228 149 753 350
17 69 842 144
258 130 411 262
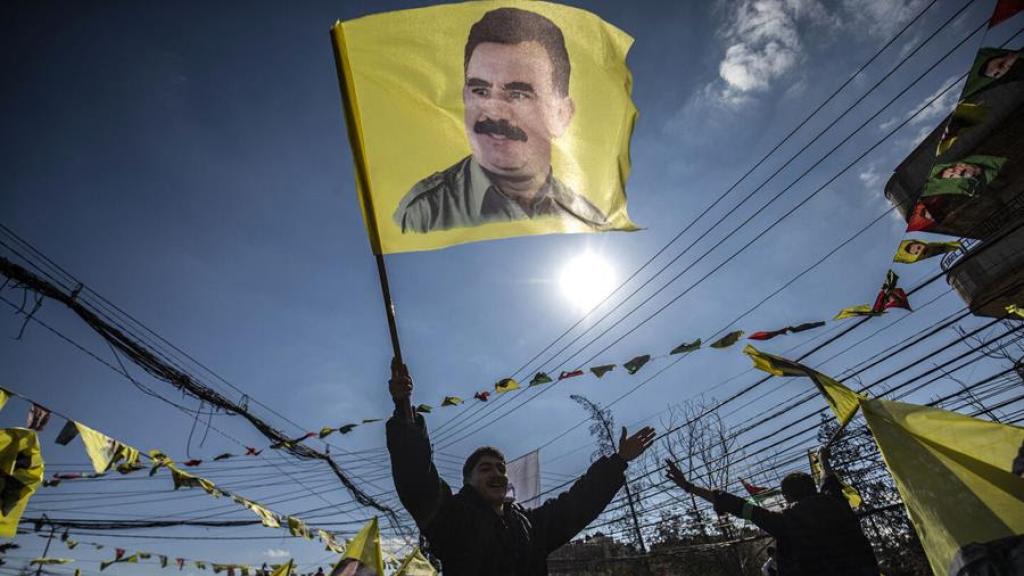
0 428 45 538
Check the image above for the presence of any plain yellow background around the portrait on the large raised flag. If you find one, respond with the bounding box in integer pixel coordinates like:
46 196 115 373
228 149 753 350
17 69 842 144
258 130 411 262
332 0 637 253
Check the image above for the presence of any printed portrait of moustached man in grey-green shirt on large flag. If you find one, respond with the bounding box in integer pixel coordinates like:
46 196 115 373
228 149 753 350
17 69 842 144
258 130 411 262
394 8 609 234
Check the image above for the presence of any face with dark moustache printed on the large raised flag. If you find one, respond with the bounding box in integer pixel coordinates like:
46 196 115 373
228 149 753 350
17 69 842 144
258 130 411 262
463 41 573 180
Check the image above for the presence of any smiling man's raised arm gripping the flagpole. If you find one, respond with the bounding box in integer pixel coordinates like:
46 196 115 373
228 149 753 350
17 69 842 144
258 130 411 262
387 362 452 531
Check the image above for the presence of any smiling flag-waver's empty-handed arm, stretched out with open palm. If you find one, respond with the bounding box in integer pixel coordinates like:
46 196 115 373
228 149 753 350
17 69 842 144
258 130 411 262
526 427 654 552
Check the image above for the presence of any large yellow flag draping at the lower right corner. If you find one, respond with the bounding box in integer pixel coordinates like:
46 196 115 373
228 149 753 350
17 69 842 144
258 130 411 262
861 400 1024 574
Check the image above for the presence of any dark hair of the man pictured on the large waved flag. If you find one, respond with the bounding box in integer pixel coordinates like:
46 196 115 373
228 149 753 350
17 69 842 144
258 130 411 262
463 8 570 96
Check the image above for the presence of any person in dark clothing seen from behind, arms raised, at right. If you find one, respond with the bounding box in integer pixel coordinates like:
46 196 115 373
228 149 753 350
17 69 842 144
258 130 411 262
666 448 879 576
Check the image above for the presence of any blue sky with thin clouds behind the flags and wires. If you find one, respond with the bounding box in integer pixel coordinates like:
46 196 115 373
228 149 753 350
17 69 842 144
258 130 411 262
0 0 1019 573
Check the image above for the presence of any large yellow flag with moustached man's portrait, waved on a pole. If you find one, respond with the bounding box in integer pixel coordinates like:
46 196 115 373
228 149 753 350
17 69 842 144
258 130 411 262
332 0 637 253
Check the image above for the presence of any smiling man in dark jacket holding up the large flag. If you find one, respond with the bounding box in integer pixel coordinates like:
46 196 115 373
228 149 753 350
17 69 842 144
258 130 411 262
387 362 654 576
